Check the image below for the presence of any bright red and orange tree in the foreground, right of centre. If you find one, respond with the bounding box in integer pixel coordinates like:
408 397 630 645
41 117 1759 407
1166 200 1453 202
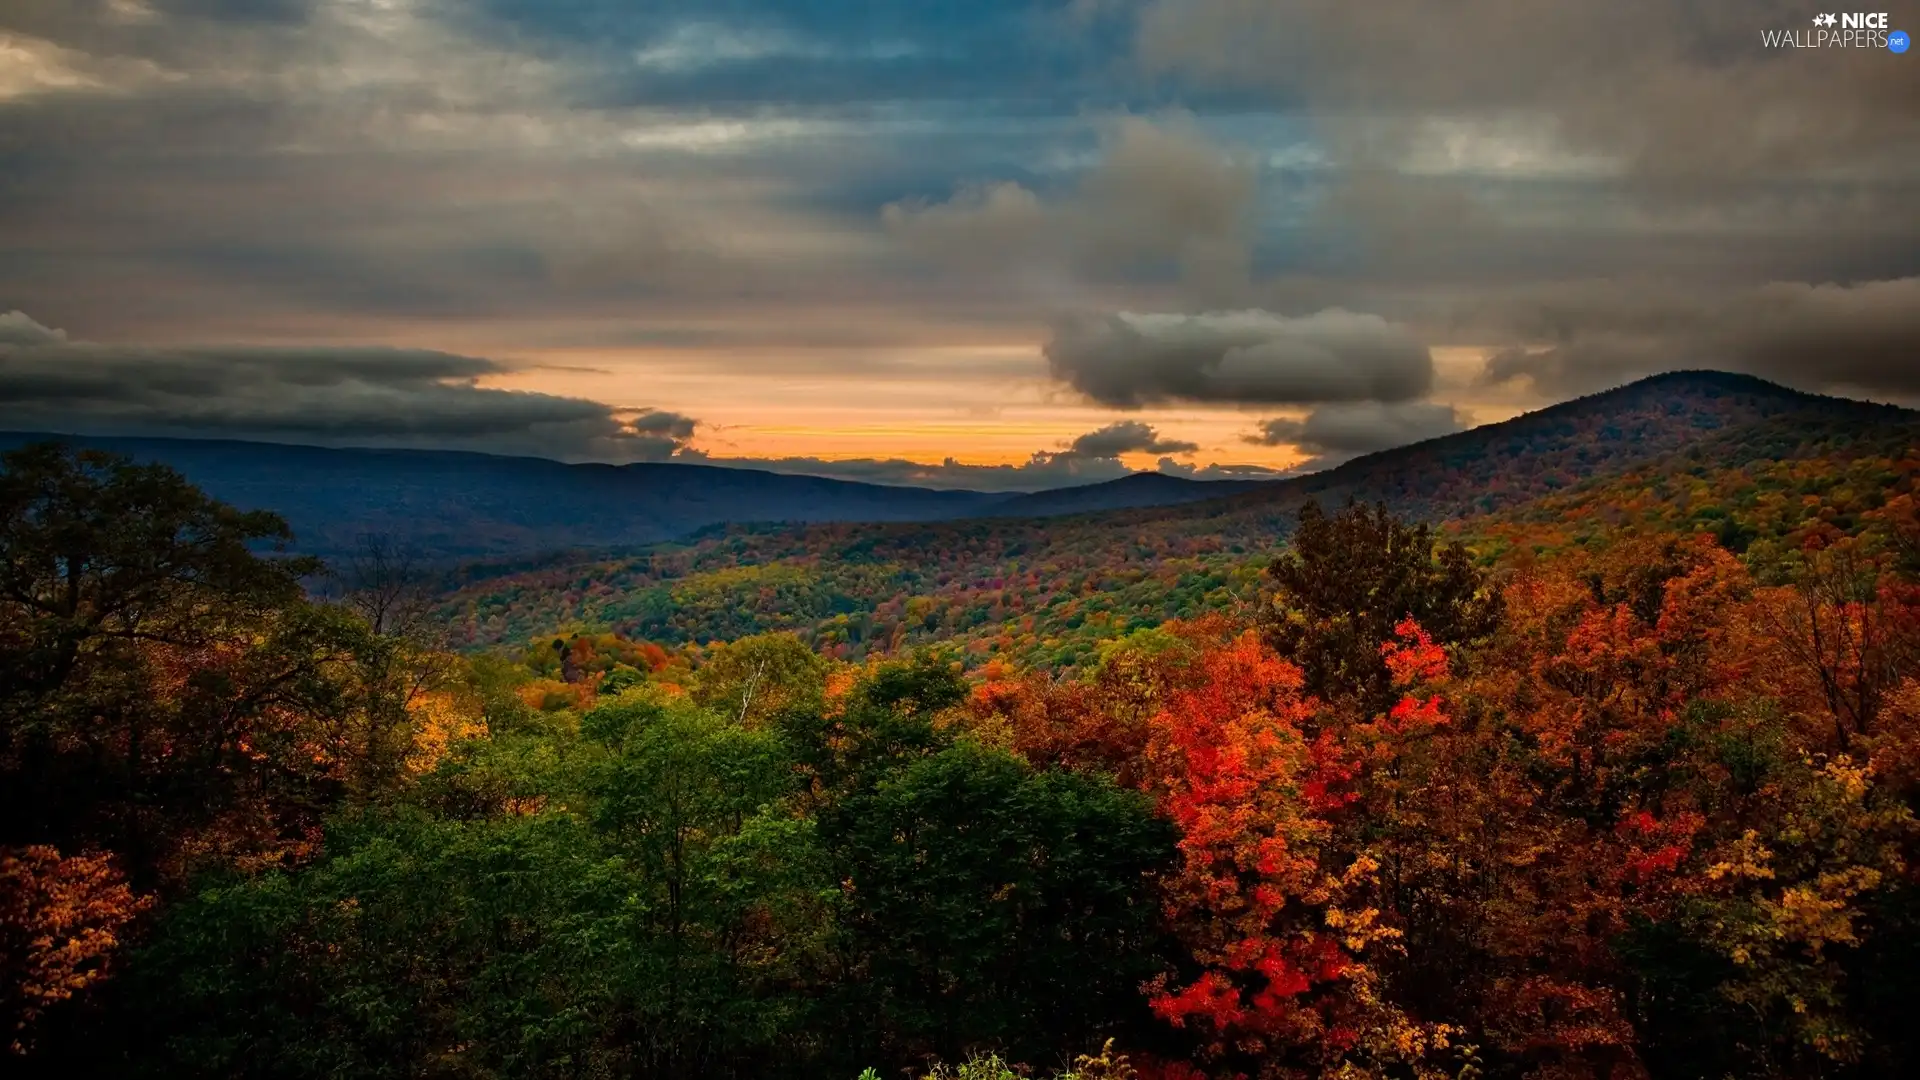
1146 632 1448 1076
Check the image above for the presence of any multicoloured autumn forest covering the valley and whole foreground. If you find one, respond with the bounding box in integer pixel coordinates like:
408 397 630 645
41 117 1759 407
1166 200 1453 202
0 430 1920 1080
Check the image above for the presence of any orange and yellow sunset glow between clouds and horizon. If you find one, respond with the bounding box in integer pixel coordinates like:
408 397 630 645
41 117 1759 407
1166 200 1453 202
460 342 1524 469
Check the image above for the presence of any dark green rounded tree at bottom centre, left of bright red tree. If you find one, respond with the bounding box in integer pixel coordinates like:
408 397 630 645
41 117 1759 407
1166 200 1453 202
822 740 1173 1059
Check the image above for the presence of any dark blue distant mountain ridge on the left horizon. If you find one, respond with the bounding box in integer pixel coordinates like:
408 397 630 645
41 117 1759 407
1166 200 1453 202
0 432 1004 559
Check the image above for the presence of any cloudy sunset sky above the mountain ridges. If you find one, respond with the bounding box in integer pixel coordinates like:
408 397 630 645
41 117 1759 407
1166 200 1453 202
0 0 1920 490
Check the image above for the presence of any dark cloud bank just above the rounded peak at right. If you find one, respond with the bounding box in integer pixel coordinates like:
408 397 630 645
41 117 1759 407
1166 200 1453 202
1467 277 1920 398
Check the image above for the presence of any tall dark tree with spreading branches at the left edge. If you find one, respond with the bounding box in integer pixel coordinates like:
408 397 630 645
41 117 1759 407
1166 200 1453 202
0 444 351 888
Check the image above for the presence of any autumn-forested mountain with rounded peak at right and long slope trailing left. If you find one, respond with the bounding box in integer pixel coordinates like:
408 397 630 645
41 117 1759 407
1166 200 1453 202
444 373 1920 667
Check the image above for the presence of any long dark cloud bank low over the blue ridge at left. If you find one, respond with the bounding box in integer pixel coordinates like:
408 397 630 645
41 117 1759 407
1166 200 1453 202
0 311 695 461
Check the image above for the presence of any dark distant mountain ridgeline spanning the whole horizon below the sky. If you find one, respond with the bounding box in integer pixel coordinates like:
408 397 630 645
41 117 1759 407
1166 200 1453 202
11 371 1916 563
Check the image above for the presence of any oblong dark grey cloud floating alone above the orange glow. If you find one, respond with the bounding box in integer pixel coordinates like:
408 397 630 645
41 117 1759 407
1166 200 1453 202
1044 309 1434 409
